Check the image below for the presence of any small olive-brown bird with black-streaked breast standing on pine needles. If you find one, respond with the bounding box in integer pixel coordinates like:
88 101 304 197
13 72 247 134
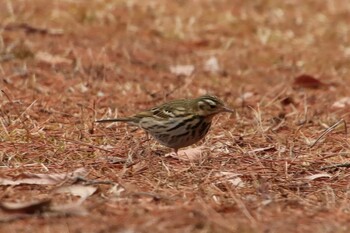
95 95 234 155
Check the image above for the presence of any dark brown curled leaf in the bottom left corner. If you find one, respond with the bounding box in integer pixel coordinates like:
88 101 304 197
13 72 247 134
0 199 51 214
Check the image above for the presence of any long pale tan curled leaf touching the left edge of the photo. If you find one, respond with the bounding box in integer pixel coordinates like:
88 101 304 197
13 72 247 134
0 168 86 185
